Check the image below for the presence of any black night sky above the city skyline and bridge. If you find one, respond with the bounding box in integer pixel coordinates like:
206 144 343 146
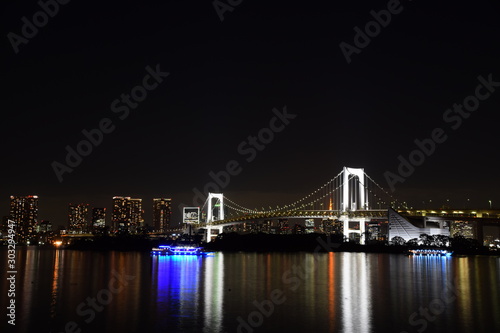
0 0 500 225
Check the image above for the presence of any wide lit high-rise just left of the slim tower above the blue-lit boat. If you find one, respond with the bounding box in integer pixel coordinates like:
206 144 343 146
112 197 144 231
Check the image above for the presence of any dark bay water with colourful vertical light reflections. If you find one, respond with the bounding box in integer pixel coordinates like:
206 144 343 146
0 248 500 333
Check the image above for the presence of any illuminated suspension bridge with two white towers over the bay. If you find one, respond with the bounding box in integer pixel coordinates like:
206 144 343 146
191 167 397 242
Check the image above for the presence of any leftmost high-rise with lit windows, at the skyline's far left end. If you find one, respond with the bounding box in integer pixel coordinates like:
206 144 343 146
10 195 38 243
